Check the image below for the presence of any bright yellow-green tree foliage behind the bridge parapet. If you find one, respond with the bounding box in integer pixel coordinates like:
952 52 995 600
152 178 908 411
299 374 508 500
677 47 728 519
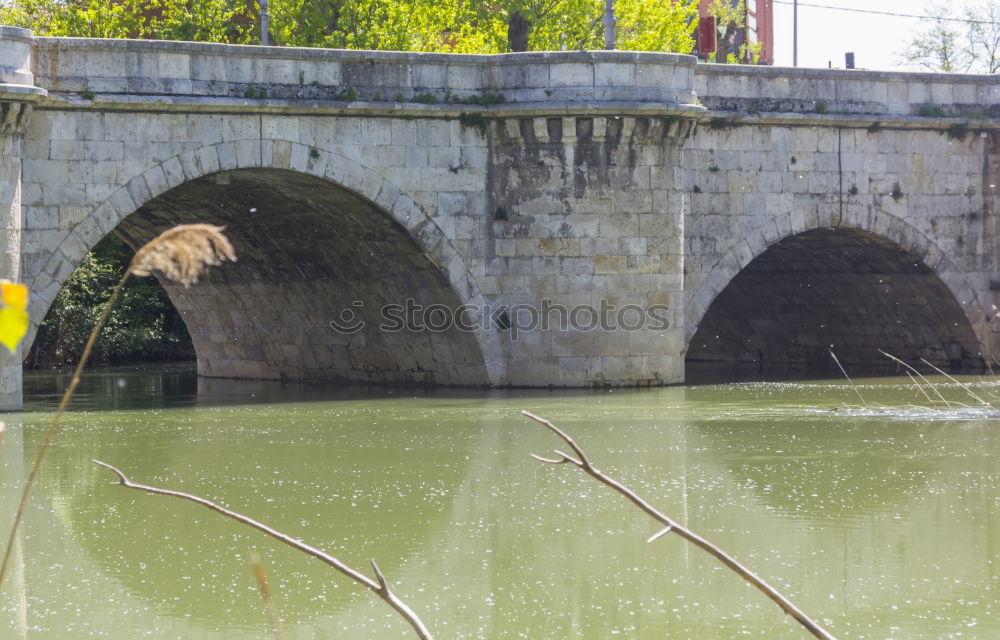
0 0 697 53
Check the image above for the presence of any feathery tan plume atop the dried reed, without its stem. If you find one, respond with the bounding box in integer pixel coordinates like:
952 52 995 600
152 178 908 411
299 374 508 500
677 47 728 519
129 224 236 287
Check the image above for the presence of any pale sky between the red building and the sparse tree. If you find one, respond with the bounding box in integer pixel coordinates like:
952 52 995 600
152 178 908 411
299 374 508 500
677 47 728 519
773 0 970 71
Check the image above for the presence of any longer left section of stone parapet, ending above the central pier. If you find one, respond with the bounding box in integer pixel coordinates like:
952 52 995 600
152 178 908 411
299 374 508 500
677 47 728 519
35 38 696 105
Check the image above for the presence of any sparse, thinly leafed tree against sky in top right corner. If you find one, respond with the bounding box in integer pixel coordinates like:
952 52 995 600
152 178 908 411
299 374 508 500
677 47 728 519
902 1 1000 73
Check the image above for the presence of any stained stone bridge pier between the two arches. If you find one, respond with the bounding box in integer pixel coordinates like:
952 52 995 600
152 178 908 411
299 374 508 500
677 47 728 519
484 112 699 387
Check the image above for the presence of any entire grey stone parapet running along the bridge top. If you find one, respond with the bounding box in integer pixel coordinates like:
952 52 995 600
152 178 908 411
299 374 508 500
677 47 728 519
23 32 1000 124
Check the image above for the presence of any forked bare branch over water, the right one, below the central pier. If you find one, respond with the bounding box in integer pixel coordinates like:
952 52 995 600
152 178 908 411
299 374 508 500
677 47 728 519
521 411 836 640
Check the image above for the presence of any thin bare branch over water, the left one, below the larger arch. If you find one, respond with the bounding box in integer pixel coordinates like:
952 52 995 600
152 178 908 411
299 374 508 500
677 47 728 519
91 460 433 640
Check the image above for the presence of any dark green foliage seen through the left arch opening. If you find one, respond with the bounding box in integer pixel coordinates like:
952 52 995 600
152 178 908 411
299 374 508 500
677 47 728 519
25 234 194 367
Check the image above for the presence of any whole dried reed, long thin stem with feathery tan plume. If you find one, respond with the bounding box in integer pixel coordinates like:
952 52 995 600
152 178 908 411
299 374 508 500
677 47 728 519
0 224 236 585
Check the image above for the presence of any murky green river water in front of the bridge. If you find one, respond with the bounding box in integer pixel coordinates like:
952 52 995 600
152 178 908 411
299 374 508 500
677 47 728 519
0 368 1000 640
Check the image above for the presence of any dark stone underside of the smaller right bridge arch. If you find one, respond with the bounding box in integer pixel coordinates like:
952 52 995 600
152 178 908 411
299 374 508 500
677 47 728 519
685 229 984 382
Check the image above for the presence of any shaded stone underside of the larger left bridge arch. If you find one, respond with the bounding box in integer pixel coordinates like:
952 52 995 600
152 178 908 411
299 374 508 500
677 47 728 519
114 169 487 386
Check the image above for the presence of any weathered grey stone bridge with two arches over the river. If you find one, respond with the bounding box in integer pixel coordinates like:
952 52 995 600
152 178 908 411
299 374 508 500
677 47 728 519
0 27 1000 407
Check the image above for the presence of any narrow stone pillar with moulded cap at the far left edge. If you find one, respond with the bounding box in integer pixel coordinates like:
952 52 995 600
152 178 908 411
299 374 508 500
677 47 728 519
0 26 46 411
